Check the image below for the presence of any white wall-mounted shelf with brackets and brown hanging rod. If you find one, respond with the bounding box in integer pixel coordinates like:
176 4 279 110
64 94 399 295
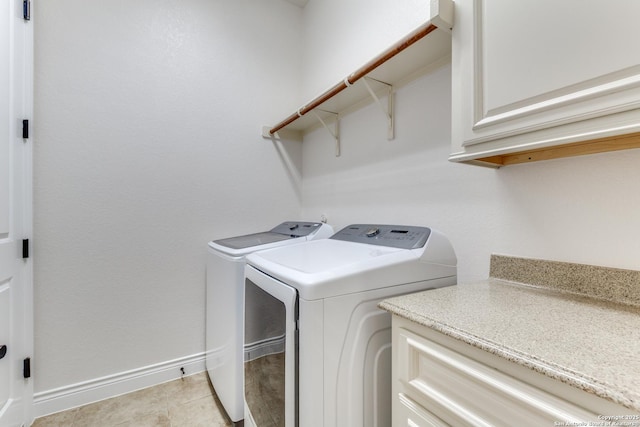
262 0 453 156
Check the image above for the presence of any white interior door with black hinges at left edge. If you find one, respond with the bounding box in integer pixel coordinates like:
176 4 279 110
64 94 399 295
0 0 33 427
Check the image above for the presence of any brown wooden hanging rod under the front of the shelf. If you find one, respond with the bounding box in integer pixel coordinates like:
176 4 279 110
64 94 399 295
269 21 438 135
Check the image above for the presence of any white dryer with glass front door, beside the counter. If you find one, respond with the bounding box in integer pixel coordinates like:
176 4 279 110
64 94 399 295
245 224 456 427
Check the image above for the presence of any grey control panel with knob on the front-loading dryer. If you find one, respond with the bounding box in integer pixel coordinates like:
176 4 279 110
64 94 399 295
330 224 431 249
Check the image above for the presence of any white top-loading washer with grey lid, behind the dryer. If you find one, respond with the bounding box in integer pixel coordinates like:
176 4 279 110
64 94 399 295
205 221 333 425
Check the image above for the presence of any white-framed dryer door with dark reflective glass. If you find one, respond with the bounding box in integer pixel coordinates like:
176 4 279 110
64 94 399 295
244 266 298 427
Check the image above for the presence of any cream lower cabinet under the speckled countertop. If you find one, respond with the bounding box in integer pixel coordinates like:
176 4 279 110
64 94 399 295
392 316 640 427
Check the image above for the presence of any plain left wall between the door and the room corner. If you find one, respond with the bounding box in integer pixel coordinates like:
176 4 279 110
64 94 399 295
33 0 301 392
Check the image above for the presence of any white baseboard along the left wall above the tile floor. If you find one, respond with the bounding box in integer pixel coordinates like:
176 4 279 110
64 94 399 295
33 353 205 418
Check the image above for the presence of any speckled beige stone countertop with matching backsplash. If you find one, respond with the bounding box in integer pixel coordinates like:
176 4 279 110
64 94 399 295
380 256 640 411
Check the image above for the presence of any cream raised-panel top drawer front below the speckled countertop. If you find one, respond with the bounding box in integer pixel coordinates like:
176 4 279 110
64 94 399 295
397 328 599 427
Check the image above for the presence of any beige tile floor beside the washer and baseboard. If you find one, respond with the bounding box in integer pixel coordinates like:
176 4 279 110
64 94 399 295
33 372 232 427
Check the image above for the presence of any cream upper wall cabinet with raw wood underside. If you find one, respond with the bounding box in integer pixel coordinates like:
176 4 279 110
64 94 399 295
450 0 640 166
